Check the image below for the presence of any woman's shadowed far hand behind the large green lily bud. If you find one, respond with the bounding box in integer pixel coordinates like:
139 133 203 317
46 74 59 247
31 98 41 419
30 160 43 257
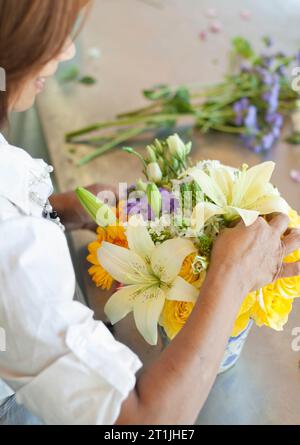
50 184 117 231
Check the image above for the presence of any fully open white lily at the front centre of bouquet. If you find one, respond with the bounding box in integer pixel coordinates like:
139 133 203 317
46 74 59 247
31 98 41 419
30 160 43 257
98 216 199 345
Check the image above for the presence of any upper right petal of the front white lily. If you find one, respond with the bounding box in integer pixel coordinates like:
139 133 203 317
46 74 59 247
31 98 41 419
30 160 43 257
151 238 197 283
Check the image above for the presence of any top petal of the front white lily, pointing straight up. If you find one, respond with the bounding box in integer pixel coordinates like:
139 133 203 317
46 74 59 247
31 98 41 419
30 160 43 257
126 215 155 263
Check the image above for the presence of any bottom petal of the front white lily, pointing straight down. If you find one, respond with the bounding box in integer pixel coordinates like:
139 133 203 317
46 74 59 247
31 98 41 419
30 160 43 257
133 287 166 346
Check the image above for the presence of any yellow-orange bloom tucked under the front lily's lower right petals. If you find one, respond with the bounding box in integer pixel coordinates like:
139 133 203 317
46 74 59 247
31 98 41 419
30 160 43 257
160 300 195 340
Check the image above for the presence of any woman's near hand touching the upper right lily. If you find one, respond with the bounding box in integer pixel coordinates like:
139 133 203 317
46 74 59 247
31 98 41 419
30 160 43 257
209 214 300 297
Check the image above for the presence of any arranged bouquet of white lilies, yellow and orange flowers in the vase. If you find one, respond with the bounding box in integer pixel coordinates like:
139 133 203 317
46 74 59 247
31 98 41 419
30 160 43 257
77 135 300 345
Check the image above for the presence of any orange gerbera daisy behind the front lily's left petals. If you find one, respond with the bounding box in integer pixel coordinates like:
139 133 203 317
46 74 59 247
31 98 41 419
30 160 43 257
87 225 128 290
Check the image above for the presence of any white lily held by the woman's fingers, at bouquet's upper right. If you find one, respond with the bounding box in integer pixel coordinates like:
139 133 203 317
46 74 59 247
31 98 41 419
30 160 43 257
188 162 290 231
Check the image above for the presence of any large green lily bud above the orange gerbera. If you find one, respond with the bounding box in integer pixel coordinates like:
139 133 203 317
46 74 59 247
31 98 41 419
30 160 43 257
76 187 117 227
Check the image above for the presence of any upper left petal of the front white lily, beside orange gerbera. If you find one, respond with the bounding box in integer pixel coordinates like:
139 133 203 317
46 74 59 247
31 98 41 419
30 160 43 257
98 242 149 284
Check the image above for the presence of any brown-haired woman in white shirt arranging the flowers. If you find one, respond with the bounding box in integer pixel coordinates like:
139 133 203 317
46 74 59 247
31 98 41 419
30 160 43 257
0 0 300 424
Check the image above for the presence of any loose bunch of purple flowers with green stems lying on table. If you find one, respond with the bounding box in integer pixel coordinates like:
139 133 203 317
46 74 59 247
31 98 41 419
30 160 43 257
66 37 300 166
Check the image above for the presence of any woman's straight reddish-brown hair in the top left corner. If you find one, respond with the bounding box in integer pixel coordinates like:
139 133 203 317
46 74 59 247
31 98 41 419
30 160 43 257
0 0 89 128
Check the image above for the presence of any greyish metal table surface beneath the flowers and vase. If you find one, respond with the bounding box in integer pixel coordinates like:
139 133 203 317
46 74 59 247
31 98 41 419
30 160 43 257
38 0 300 424
